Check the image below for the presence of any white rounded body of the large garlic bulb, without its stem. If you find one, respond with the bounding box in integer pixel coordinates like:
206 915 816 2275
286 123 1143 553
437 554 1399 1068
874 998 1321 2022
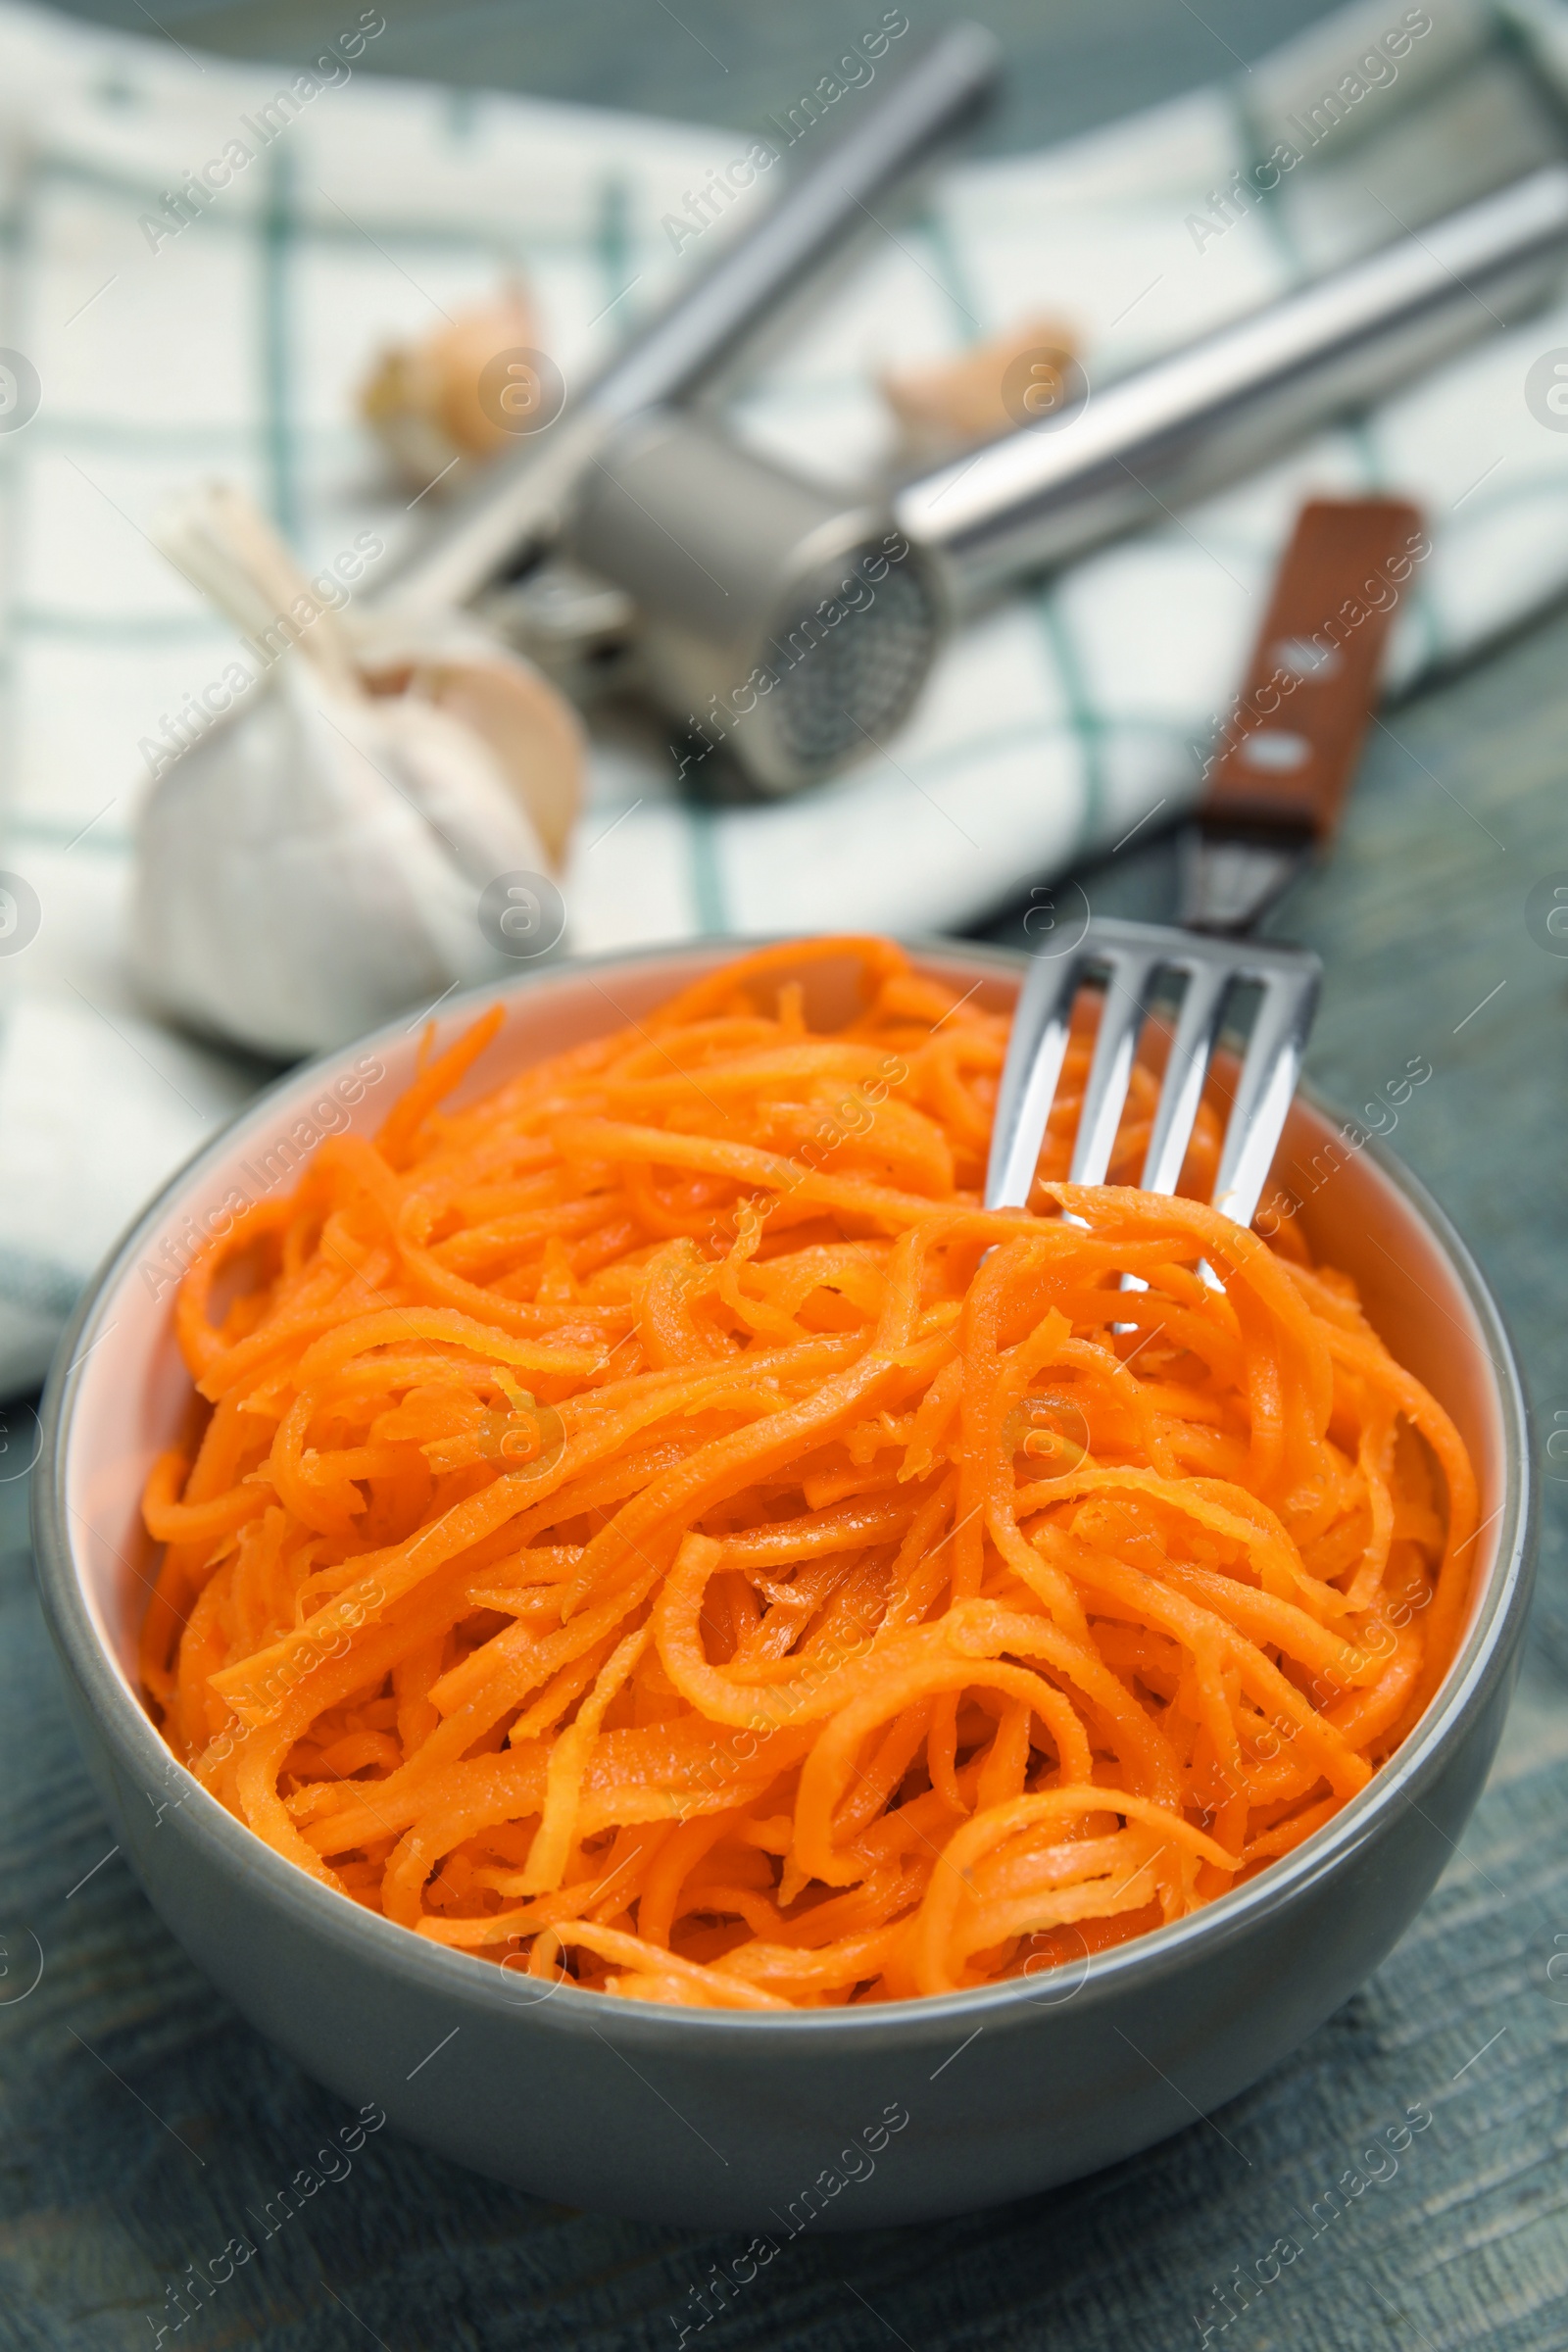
131 661 546 1058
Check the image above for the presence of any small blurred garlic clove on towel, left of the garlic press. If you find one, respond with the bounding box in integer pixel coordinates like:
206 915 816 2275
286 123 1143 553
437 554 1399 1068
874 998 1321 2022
360 280 538 487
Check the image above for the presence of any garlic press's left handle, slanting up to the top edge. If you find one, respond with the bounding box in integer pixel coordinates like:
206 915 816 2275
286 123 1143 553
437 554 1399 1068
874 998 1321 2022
381 24 1002 607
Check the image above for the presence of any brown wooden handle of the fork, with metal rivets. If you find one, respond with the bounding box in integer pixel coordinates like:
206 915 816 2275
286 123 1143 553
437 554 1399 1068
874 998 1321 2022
1199 499 1429 842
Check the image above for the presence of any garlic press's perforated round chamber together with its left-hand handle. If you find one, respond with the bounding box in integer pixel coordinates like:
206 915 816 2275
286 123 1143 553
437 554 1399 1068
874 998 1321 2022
381 24 999 790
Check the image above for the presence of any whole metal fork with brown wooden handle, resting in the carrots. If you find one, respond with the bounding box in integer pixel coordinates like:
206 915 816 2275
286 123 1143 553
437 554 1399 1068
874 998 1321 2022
985 499 1425 1225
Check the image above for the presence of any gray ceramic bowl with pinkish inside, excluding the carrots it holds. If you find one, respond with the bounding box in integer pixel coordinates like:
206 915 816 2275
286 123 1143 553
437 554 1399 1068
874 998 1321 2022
35 943 1533 2241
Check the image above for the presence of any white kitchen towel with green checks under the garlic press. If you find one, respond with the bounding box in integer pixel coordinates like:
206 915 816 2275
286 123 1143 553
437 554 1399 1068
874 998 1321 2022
0 0 1568 1393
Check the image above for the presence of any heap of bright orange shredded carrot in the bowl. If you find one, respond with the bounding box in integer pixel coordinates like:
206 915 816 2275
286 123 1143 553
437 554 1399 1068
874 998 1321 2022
141 941 1476 2009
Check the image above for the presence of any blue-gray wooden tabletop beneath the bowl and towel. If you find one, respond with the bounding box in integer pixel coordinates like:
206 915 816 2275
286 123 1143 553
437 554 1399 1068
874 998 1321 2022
0 0 1568 2352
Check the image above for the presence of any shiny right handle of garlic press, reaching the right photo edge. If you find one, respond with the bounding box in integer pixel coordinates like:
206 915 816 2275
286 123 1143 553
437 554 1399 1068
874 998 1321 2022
894 165 1568 607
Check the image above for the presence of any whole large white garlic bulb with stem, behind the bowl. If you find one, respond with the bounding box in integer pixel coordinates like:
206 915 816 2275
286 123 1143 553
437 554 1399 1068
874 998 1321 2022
131 487 583 1058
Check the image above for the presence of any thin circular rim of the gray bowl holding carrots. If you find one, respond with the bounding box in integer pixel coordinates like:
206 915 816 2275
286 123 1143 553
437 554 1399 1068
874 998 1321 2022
33 934 1538 2046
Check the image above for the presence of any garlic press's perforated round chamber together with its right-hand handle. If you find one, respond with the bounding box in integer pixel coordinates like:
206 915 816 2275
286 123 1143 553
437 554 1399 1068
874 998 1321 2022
484 167 1568 793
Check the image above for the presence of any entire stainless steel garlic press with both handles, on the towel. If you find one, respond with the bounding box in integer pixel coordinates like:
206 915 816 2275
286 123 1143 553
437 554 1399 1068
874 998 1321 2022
375 25 1568 793
